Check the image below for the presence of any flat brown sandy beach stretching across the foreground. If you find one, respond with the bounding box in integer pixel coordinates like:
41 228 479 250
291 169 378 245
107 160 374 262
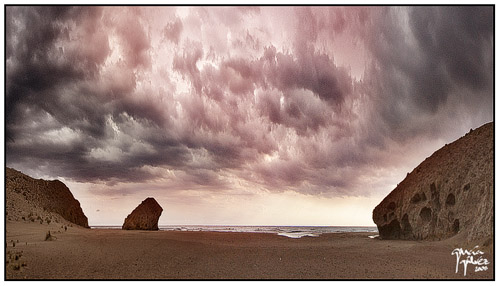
6 221 494 279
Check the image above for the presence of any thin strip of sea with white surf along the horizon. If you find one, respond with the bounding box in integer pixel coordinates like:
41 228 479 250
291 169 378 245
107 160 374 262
91 225 378 238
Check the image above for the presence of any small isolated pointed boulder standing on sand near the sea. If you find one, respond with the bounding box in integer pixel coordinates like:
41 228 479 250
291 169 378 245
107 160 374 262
122 198 163 230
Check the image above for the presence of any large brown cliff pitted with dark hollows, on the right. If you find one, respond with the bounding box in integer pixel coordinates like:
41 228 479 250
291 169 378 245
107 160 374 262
373 123 494 245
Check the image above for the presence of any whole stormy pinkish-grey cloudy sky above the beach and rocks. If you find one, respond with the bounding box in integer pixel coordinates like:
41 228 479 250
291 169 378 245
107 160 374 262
5 6 494 225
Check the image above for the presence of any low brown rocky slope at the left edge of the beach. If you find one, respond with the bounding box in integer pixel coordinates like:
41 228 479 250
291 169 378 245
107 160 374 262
5 168 89 227
